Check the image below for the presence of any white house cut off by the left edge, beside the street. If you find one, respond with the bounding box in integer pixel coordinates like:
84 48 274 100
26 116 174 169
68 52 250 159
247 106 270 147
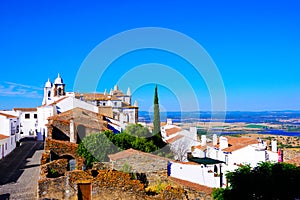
0 111 19 159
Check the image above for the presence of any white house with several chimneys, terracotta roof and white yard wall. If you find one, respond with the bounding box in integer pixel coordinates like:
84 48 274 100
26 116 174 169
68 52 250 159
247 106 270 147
169 135 278 187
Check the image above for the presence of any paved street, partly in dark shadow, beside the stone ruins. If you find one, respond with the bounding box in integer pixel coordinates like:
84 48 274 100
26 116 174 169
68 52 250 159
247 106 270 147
0 141 44 200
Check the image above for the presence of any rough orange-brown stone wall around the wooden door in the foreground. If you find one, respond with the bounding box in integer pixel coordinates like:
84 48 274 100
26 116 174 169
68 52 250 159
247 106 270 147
38 170 147 200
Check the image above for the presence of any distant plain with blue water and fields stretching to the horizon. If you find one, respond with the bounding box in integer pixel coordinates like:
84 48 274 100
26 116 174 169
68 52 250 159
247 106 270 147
139 111 300 136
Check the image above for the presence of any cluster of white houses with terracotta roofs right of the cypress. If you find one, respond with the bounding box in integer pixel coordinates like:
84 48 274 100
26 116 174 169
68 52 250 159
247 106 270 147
161 119 282 188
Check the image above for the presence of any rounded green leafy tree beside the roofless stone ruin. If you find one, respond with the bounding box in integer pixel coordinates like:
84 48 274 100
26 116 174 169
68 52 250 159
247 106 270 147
77 131 117 167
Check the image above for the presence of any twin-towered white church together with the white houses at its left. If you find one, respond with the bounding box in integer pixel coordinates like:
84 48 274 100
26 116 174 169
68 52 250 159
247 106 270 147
0 74 138 159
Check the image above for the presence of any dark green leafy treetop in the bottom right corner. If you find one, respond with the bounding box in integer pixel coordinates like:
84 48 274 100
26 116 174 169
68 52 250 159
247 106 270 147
212 162 300 200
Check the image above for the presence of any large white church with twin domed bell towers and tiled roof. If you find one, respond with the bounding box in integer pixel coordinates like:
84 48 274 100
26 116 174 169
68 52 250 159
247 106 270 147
37 74 138 138
